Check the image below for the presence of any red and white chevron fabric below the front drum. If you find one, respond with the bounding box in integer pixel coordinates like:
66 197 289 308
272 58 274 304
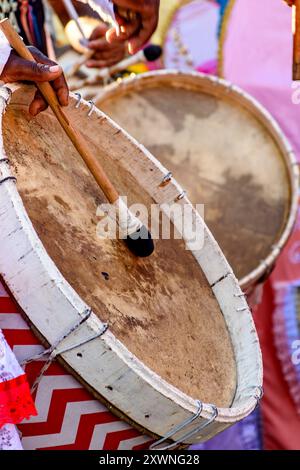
0 281 150 450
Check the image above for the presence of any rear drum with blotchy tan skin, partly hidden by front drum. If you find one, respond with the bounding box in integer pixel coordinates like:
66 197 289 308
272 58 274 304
96 71 298 288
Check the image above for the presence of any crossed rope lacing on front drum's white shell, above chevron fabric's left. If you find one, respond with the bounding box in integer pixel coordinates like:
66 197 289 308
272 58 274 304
21 308 108 393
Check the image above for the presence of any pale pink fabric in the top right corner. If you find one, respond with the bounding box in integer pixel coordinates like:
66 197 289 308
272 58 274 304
223 0 300 158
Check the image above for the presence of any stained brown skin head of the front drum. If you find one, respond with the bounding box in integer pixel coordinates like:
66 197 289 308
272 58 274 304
3 85 236 407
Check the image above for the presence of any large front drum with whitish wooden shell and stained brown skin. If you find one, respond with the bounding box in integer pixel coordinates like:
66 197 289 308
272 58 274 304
0 86 262 446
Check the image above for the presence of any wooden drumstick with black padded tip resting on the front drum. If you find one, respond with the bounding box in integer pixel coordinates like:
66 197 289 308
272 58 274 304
0 18 154 257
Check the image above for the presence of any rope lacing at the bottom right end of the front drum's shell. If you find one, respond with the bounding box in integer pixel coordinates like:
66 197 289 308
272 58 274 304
150 400 218 450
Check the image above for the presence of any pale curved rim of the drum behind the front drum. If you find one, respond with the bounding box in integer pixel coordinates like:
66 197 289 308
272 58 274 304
95 69 300 289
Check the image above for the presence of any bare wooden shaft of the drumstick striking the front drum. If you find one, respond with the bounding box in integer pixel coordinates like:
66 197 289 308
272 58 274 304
0 18 119 204
